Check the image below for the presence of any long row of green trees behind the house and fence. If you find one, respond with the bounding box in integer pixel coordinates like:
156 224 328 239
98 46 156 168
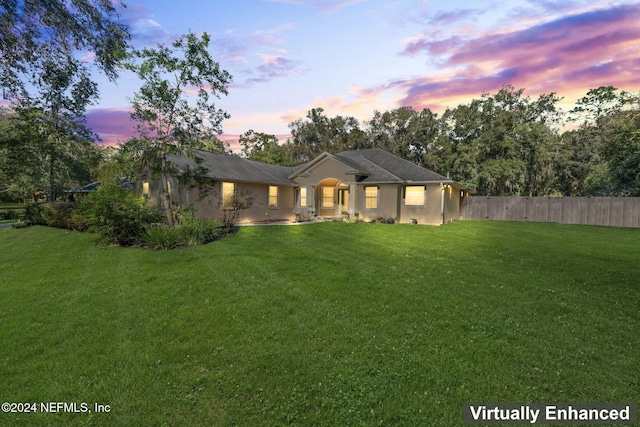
240 85 640 196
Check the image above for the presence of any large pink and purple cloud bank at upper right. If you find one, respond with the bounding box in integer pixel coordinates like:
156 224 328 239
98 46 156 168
377 5 640 112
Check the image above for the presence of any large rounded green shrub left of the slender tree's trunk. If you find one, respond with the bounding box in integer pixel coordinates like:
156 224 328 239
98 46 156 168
79 184 163 246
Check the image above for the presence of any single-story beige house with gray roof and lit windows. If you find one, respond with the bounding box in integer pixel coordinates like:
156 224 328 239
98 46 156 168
137 148 470 225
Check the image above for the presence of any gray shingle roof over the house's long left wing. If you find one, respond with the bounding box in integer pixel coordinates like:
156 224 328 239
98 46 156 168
169 150 297 185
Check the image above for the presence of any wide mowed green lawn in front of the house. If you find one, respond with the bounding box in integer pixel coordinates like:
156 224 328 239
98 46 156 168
0 221 640 426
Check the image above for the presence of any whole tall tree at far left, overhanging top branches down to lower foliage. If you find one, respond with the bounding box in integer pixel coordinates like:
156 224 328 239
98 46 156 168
0 0 129 201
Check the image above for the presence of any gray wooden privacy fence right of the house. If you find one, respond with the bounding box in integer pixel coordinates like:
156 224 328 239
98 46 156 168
460 196 640 228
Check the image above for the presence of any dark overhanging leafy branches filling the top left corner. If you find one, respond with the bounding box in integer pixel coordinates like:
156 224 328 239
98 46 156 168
0 0 130 99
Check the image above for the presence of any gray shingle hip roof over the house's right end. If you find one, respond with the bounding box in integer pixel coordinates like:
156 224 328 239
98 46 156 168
334 148 451 182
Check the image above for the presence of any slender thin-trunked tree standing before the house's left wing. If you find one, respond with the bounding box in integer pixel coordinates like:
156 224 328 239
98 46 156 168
125 33 231 225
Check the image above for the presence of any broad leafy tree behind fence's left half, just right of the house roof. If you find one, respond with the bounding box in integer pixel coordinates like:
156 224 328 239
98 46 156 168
442 86 560 196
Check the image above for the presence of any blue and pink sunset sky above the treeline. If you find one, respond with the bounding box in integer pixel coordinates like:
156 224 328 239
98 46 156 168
87 0 640 148
